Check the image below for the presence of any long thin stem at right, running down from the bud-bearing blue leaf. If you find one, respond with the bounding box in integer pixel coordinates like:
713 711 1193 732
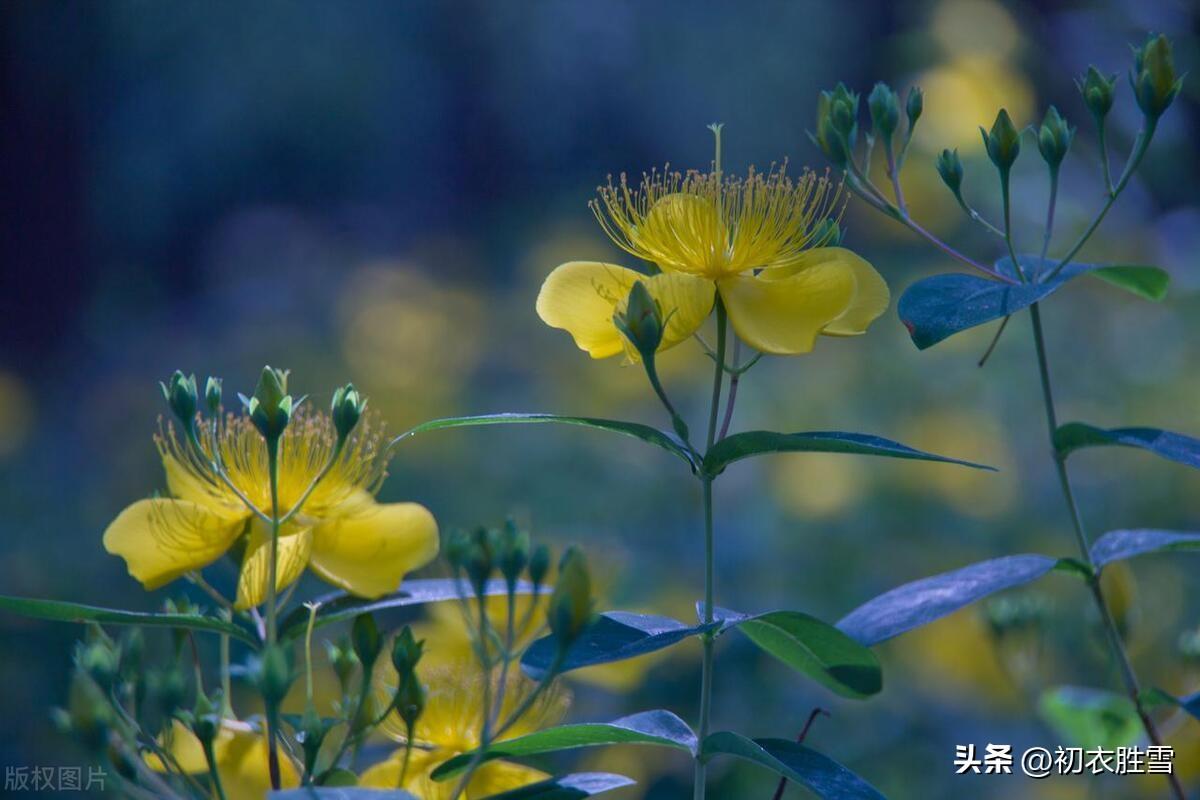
1030 303 1184 800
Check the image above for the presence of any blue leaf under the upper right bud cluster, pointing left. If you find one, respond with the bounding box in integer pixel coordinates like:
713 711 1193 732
896 255 1097 350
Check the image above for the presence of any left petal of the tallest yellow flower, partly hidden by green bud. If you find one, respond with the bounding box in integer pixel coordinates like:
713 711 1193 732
538 261 713 359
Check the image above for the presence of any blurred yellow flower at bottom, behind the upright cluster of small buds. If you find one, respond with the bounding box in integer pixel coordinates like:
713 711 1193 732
359 661 566 800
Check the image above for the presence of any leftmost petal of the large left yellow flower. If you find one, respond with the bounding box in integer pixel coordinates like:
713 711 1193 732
104 498 244 590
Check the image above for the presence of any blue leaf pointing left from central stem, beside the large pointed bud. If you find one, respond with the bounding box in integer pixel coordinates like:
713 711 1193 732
521 612 720 680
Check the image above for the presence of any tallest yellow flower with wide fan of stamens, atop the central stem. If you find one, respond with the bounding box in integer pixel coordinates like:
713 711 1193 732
538 168 889 360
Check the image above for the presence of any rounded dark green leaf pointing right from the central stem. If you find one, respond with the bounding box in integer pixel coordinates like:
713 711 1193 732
714 609 883 699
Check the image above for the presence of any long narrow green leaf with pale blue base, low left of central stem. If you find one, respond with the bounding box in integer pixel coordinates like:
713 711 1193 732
431 710 696 781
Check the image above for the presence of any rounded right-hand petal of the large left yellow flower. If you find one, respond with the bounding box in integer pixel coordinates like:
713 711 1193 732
312 503 438 597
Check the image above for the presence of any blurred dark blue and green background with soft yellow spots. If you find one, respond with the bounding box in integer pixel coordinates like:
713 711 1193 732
0 0 1200 800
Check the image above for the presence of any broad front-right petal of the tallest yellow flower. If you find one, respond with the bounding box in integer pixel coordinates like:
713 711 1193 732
718 260 857 355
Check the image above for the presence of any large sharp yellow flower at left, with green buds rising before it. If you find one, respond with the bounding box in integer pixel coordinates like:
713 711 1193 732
104 411 438 608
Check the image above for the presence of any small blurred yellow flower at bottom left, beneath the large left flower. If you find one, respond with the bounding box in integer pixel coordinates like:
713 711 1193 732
146 720 300 800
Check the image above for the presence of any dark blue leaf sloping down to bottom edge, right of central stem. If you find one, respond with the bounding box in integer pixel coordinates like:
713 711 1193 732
701 730 884 800
